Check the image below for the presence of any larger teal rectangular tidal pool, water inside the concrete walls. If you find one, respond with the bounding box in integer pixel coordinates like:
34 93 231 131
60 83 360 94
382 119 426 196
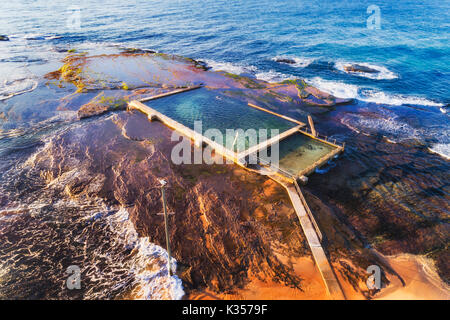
144 88 298 152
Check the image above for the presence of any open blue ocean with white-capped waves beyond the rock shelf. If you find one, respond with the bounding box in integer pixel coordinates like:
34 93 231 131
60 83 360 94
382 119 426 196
0 0 450 157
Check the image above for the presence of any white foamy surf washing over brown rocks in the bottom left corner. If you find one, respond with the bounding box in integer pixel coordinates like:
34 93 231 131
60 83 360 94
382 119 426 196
0 135 184 300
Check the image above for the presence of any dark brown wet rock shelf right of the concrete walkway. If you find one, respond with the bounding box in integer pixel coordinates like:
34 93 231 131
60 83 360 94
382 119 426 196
305 135 450 283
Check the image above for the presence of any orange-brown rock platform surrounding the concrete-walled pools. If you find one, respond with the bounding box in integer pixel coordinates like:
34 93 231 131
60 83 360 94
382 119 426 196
9 49 449 298
